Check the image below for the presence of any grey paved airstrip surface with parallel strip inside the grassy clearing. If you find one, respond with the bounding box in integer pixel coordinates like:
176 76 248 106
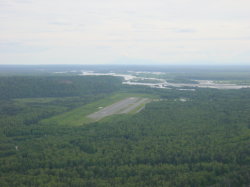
87 97 149 121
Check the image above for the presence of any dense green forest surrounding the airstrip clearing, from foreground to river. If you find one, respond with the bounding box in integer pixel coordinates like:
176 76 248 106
0 76 250 187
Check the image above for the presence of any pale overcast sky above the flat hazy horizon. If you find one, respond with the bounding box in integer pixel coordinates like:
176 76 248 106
0 0 250 65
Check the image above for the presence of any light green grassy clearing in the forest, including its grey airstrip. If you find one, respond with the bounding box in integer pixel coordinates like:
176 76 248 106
41 93 153 126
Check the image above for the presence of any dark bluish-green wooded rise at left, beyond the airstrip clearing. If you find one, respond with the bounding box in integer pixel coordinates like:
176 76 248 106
0 76 121 99
